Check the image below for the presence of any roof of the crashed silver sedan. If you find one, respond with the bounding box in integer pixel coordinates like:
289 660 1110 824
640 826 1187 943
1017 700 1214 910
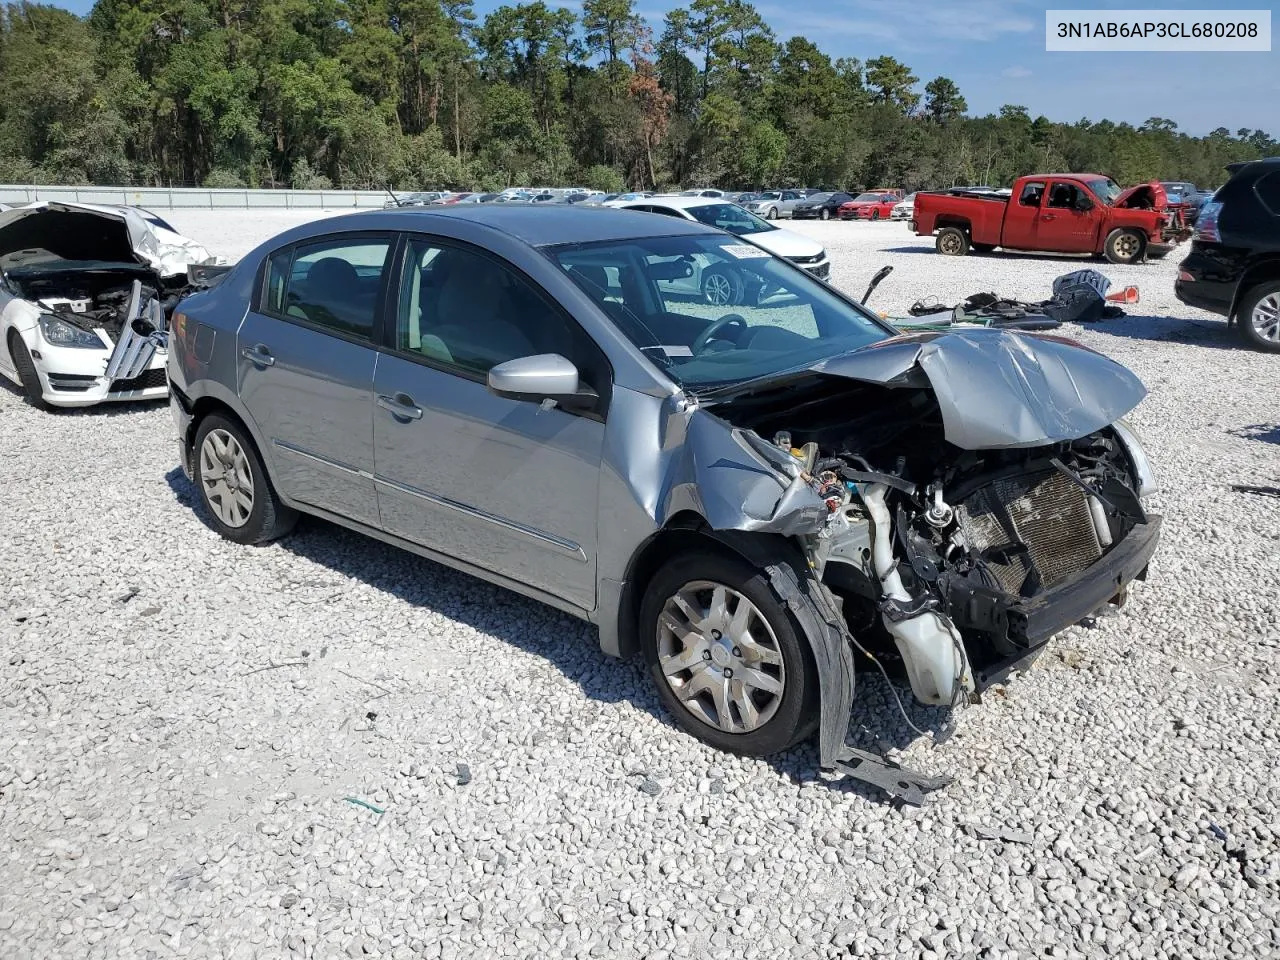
302 206 723 247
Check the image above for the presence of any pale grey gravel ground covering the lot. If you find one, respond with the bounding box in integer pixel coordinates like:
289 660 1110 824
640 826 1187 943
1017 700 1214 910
0 212 1280 960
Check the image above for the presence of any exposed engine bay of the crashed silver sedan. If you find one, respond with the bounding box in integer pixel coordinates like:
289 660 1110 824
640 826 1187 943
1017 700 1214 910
716 363 1158 705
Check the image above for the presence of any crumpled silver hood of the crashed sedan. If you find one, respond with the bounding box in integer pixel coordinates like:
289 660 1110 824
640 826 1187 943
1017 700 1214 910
810 329 1147 451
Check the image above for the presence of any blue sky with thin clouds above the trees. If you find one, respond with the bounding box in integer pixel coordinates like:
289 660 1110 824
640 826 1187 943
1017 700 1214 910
47 0 1280 136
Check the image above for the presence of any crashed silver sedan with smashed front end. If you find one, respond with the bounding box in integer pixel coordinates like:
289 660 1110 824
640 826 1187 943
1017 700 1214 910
169 205 1160 767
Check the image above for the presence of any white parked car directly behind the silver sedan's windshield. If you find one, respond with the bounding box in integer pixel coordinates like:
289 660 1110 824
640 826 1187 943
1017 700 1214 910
623 197 831 289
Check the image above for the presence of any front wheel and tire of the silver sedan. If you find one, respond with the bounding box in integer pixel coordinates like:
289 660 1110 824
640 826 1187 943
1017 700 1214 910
640 550 818 756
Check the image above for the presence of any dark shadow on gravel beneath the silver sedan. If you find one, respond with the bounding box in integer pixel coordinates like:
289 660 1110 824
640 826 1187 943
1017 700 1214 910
165 467 951 804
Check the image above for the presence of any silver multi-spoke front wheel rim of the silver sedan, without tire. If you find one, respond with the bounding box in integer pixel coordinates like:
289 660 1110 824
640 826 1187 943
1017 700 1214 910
658 580 786 733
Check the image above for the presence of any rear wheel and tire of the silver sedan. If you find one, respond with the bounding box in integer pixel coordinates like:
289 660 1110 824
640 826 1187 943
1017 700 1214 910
191 413 298 544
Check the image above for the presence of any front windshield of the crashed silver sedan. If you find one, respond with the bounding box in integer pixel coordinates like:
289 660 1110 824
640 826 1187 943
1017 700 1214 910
550 234 891 393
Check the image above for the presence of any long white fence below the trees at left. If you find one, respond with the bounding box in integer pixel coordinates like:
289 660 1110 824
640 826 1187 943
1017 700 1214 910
0 184 389 210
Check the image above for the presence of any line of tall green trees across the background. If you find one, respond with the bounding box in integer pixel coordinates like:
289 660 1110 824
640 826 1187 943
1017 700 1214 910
0 0 1280 191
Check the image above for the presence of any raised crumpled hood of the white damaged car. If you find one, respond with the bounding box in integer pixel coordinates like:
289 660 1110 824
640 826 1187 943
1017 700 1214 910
0 201 212 276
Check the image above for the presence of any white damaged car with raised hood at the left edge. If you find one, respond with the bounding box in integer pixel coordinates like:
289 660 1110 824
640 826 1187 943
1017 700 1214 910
0 201 215 410
